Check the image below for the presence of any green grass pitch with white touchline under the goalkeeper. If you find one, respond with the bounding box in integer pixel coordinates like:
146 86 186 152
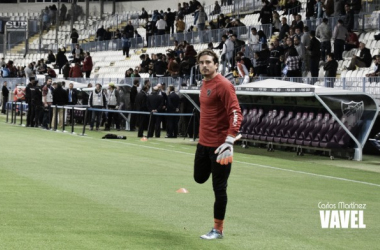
0 116 380 250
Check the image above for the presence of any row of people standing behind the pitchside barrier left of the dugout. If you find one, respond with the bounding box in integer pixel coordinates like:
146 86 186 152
2 78 196 138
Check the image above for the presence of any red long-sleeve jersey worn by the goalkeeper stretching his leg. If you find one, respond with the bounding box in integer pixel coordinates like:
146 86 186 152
199 74 242 147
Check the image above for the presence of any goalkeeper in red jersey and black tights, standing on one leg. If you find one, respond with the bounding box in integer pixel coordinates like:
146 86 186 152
194 50 242 240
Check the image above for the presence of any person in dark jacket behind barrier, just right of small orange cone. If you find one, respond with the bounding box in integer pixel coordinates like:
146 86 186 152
146 86 164 138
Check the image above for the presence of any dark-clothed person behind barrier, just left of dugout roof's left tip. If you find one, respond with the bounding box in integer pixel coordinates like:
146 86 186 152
165 86 181 138
